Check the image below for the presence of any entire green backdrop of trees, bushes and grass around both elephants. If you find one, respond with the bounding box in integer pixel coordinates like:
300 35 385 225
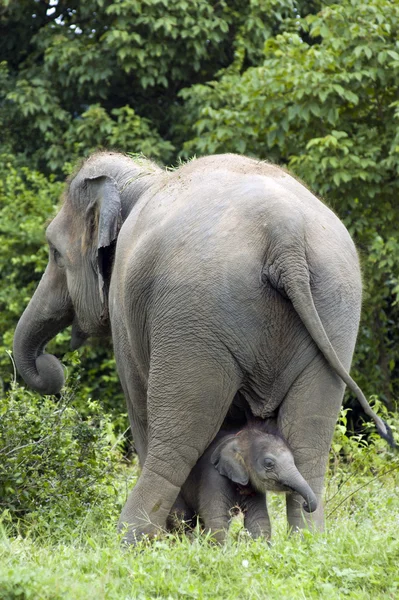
0 0 399 600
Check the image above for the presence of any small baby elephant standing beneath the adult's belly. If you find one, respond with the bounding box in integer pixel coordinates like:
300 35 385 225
173 426 317 542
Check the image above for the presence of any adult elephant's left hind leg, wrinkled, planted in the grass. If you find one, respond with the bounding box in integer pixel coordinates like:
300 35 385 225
120 346 240 542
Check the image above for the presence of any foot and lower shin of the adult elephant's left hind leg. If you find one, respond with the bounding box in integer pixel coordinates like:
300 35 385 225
118 467 179 545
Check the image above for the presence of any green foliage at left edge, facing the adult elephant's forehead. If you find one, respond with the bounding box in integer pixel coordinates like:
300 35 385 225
0 155 63 381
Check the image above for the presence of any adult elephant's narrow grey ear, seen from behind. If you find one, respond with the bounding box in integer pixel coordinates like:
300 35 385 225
85 175 122 304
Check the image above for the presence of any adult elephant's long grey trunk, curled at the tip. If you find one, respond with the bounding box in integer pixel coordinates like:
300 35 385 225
13 265 73 394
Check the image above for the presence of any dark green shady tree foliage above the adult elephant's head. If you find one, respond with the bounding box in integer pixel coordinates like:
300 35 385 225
0 0 302 174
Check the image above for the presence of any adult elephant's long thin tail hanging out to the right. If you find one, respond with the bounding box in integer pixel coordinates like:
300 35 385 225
267 261 398 448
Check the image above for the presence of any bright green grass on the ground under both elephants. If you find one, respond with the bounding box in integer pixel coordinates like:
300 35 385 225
0 458 399 600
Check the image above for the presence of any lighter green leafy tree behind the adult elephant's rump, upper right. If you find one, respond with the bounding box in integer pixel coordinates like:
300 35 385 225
180 0 399 408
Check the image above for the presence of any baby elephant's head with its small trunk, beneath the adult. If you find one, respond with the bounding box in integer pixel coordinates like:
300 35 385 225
211 427 317 512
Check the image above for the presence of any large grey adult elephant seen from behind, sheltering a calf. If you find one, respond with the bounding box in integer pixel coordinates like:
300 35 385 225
14 152 389 540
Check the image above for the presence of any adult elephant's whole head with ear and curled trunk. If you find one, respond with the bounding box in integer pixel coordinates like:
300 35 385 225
14 152 161 394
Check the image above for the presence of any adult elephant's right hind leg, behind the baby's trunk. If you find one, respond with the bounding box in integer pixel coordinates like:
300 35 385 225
278 356 344 531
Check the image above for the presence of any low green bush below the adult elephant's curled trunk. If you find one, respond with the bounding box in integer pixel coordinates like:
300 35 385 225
0 378 129 534
